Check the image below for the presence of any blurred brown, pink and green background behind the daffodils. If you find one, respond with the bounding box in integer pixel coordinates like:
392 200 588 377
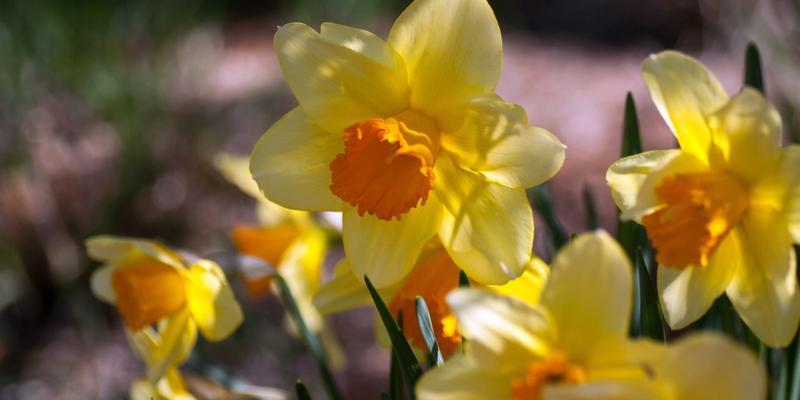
0 0 800 400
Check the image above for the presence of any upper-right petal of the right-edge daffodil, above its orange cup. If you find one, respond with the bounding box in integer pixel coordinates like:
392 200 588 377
708 88 781 182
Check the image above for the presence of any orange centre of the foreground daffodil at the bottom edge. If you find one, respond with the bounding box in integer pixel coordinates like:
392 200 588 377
511 353 586 400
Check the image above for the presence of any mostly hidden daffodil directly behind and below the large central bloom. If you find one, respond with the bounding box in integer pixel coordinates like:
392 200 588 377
314 240 549 357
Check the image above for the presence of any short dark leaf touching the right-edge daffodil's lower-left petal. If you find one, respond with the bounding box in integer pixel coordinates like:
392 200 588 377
631 251 667 342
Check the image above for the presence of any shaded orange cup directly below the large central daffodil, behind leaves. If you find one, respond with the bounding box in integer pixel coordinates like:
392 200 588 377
389 248 461 356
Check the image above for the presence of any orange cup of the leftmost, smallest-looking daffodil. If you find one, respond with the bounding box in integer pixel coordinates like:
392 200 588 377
111 262 186 332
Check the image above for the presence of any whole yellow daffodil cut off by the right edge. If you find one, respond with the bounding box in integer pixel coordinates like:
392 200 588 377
606 51 800 347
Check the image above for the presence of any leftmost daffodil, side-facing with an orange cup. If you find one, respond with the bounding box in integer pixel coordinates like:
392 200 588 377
86 236 242 385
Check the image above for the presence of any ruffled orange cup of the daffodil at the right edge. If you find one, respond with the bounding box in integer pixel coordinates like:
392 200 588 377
642 172 748 268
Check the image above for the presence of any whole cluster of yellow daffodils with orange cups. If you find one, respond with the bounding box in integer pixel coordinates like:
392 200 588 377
87 0 800 400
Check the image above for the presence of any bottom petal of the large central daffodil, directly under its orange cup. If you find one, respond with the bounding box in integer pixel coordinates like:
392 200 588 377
342 196 442 288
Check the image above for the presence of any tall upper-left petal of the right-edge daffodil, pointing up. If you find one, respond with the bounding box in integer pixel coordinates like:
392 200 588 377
642 51 728 160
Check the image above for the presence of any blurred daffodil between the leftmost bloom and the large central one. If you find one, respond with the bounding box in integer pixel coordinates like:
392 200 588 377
214 153 345 367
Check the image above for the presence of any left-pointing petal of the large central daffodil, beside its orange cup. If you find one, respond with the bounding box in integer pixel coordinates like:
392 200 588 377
250 107 344 211
